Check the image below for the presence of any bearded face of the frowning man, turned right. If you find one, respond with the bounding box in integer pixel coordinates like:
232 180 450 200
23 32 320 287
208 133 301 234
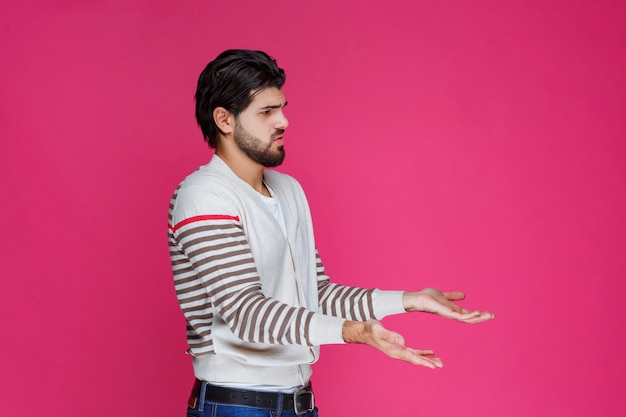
233 88 289 167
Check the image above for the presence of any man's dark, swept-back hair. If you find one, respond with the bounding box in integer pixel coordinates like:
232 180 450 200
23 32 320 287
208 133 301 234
195 49 285 148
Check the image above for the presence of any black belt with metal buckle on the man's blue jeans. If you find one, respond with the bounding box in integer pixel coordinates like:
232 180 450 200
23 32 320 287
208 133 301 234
189 379 315 415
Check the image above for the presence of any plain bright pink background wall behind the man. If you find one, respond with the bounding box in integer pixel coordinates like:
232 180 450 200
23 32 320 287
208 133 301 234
0 0 626 417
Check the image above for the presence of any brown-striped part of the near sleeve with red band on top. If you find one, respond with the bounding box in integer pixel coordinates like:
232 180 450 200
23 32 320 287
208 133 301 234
169 192 330 355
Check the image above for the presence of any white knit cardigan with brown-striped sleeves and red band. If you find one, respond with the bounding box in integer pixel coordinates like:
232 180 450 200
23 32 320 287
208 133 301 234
169 156 404 386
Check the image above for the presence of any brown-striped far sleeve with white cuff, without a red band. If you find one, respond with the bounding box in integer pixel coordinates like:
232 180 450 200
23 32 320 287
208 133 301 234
315 250 404 321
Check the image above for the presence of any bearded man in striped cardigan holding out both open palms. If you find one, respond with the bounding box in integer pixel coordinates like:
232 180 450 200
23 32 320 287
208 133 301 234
169 50 493 417
